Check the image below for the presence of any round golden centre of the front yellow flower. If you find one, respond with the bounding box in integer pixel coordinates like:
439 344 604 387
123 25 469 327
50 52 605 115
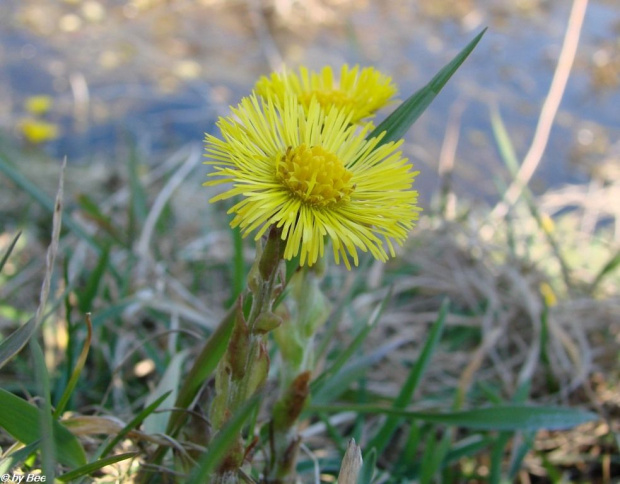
276 144 355 207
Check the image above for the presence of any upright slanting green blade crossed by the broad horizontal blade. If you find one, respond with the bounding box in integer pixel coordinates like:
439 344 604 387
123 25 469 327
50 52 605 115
368 301 449 454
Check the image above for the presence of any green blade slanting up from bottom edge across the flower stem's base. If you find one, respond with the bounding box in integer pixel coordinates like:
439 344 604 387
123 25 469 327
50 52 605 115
185 395 261 484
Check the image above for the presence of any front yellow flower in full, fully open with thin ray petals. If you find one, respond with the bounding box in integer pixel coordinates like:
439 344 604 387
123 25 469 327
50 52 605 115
205 95 420 268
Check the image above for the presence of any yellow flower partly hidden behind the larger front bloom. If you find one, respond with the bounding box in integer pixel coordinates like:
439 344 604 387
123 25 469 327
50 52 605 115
255 64 397 124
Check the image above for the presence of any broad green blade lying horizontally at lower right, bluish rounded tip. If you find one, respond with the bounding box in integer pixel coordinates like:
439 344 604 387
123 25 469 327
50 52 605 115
307 404 598 431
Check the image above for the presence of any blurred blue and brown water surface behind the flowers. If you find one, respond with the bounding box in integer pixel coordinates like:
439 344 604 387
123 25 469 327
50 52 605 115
0 0 620 200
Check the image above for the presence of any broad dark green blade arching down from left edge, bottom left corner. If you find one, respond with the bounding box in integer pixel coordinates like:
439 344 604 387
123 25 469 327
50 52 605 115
0 388 86 468
